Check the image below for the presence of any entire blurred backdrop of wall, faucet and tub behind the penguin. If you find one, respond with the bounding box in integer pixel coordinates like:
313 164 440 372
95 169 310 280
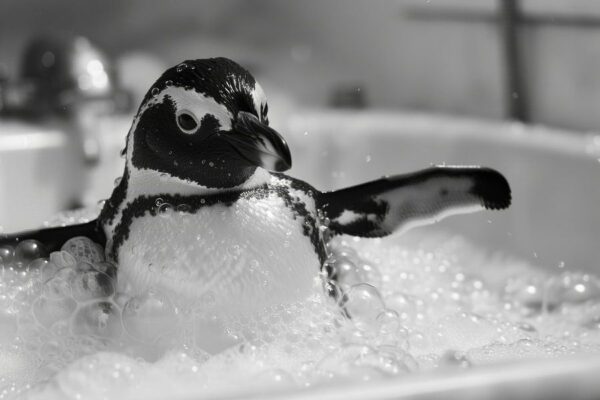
0 0 600 268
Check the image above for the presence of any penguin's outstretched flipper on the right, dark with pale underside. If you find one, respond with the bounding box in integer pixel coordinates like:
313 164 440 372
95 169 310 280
320 166 511 237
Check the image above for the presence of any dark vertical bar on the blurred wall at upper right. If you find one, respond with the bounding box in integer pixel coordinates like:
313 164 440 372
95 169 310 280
500 0 529 122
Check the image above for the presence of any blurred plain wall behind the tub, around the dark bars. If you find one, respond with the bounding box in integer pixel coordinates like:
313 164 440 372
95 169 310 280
0 0 600 131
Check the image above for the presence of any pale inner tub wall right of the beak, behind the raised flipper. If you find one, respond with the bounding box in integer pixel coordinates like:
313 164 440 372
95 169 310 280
284 112 600 272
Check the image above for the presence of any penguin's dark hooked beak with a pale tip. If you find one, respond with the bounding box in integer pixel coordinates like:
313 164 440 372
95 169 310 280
224 111 292 172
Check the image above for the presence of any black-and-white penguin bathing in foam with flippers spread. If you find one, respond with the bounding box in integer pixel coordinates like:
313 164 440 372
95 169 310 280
0 58 511 313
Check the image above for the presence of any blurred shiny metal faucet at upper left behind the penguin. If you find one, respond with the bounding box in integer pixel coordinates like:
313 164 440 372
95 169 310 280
0 34 132 166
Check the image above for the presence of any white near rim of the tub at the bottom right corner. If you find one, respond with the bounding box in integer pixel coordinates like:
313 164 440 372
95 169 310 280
198 354 600 400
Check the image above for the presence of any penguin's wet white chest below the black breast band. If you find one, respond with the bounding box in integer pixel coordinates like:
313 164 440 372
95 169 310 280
118 194 322 313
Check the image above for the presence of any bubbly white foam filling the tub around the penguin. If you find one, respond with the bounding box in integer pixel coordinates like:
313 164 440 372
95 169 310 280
0 209 600 399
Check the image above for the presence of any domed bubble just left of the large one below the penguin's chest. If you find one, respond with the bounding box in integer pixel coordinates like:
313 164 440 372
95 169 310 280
71 301 122 339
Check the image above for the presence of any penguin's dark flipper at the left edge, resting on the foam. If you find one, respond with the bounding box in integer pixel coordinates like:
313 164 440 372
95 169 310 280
0 219 106 253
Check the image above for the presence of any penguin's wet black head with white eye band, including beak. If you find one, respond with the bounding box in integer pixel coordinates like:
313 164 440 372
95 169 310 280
126 58 292 188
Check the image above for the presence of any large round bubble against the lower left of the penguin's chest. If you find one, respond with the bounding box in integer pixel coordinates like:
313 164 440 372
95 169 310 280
123 291 179 343
